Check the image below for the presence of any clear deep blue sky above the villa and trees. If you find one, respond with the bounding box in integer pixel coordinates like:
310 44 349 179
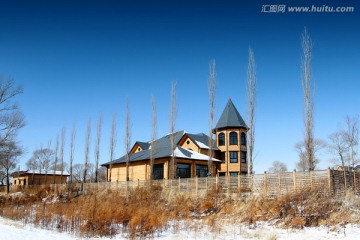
0 0 360 172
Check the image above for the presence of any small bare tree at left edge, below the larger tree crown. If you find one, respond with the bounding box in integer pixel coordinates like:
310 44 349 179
0 139 23 193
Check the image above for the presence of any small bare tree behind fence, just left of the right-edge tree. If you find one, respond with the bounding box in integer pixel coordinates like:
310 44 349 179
328 129 348 169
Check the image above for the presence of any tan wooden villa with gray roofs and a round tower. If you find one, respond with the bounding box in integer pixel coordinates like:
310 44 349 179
102 99 248 181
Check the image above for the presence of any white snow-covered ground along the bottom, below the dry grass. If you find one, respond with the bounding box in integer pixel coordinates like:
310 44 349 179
0 217 360 240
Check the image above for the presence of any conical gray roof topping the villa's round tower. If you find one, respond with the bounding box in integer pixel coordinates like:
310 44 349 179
215 99 248 129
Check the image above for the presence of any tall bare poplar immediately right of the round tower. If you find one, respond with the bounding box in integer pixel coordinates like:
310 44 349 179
247 48 257 174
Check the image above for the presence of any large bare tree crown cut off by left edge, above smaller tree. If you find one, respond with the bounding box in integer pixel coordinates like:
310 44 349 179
0 76 25 146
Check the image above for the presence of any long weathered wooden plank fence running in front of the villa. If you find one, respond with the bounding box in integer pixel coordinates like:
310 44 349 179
3 169 360 198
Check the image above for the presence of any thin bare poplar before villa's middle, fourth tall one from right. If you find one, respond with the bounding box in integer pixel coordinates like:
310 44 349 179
169 82 177 179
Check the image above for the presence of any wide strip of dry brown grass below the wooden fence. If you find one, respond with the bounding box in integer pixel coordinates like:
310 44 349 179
0 183 360 238
